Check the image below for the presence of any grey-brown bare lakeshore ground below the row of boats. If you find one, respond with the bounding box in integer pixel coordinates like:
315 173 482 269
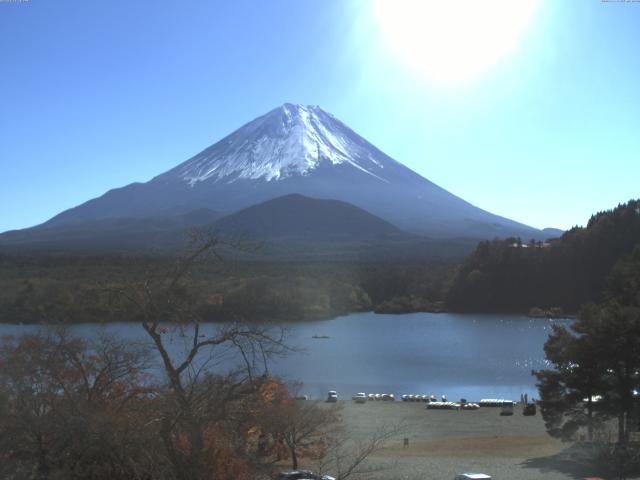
322 401 616 480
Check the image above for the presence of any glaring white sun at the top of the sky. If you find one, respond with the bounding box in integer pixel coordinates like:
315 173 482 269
374 0 537 83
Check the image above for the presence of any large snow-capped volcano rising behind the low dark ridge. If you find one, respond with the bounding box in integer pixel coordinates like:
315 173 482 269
0 104 548 251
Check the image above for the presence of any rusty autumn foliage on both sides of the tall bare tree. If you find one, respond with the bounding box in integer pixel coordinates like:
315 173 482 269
0 331 335 480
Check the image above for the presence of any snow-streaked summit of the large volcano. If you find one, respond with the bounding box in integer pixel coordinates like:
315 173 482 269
171 103 386 186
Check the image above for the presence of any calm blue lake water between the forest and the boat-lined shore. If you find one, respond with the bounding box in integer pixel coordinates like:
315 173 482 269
0 313 570 400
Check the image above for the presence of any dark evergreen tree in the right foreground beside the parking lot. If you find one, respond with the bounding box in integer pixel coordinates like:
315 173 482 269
534 247 640 478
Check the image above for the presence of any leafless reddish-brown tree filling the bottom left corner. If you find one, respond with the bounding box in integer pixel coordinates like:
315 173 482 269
0 331 163 480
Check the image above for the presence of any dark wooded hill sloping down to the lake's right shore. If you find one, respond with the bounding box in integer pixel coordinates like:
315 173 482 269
446 200 640 313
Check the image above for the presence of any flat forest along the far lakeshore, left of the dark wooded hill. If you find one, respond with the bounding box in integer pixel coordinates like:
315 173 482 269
0 255 455 323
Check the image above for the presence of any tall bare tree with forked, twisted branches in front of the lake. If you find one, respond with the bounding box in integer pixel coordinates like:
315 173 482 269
115 231 288 480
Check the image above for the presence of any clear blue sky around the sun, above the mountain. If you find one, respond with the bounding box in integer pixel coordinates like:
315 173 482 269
0 0 640 231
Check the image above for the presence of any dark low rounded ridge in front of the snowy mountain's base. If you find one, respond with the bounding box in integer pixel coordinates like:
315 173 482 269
0 194 475 261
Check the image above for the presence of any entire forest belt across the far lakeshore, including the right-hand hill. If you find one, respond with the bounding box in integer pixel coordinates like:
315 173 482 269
0 200 640 323
